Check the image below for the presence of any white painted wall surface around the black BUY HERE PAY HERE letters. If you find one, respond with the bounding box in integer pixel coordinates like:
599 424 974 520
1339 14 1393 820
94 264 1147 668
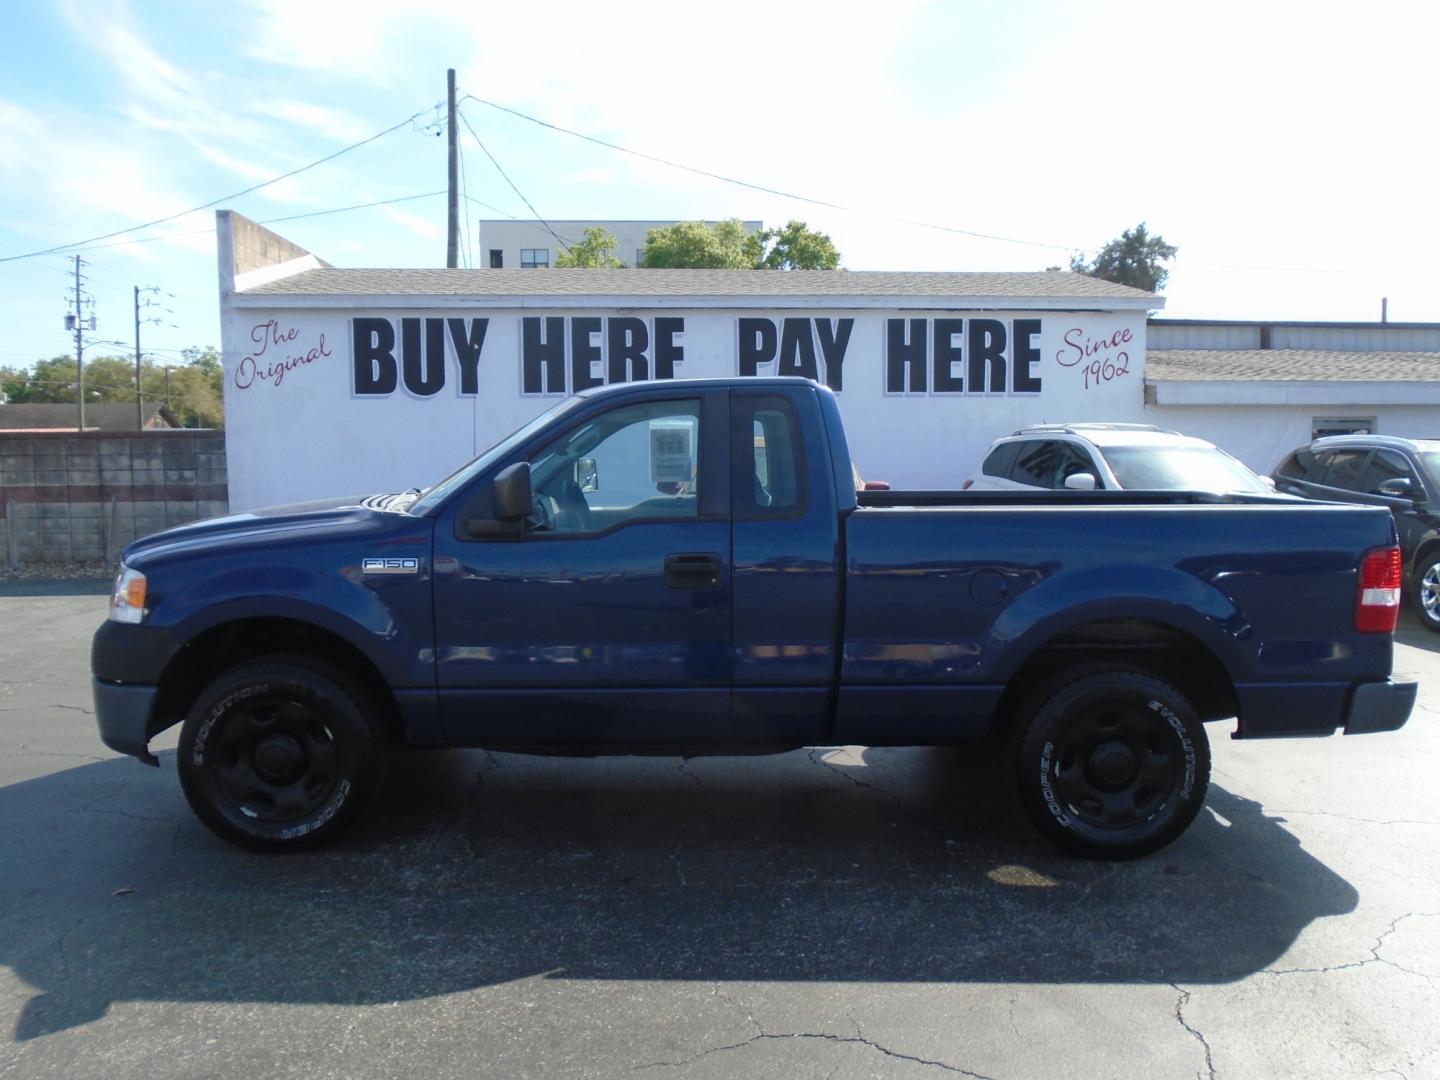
222 297 1153 510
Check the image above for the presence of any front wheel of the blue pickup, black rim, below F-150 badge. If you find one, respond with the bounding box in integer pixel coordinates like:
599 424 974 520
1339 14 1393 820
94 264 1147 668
177 657 380 851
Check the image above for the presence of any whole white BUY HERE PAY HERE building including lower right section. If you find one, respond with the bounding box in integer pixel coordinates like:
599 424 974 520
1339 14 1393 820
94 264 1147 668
217 210 1440 510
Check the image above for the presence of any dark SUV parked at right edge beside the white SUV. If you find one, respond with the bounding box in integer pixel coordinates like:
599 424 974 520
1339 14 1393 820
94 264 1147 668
1274 435 1440 631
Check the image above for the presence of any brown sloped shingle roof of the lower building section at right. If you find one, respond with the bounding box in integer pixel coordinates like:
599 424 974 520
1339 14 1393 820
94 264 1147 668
1145 348 1440 383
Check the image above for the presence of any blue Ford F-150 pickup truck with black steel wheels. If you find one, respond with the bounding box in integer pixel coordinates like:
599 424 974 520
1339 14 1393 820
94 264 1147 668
92 379 1416 858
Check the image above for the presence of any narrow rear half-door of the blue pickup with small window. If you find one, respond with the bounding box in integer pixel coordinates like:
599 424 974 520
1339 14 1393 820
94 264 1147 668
730 387 841 744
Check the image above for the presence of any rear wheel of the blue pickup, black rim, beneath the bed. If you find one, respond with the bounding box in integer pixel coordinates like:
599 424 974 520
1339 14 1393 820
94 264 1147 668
1014 670 1210 860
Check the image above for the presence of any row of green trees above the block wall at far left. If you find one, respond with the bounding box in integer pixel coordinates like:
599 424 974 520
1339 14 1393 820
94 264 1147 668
0 347 225 428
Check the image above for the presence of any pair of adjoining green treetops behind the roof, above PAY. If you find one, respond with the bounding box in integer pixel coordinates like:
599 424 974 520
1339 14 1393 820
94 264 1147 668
644 217 840 269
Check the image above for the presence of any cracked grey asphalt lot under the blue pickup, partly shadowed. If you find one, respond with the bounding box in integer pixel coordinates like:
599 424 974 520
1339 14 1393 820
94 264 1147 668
0 583 1440 1080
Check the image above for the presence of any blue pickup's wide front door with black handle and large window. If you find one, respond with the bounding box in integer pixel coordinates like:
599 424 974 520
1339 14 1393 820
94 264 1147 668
435 384 732 747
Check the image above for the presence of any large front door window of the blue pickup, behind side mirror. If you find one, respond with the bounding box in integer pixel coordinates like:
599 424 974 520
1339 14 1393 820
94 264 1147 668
530 399 700 534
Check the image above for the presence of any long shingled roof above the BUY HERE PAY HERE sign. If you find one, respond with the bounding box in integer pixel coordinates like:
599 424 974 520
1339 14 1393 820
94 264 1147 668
239 269 1153 300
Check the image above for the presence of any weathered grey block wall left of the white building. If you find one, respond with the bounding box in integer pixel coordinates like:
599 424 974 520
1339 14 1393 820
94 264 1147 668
0 431 228 569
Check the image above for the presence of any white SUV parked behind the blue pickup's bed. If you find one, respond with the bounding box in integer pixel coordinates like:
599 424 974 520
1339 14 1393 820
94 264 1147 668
965 423 1272 495
